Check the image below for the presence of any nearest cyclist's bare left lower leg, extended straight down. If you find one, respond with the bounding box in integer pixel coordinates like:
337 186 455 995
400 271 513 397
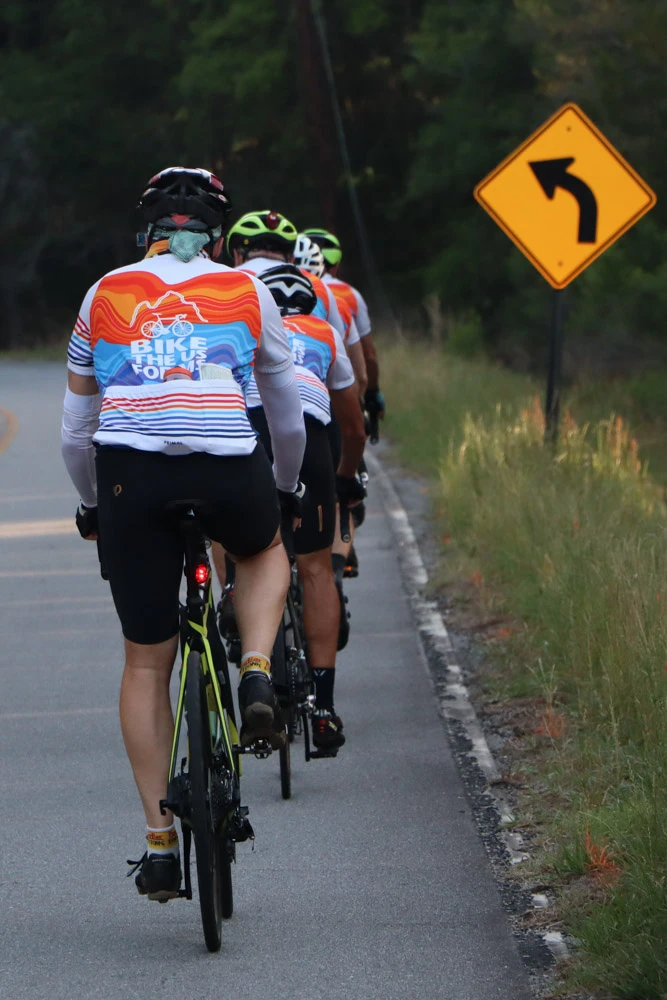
120 635 178 828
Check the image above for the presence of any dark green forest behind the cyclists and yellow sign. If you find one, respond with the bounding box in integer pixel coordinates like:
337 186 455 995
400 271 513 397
0 0 667 373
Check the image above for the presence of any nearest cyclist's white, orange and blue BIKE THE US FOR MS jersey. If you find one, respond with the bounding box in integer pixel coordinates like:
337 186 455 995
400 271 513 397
68 253 293 455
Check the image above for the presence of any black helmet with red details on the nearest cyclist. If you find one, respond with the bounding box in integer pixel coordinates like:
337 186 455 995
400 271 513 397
139 167 232 231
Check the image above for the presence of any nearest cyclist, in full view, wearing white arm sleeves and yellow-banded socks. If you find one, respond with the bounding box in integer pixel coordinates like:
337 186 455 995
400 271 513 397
62 167 305 898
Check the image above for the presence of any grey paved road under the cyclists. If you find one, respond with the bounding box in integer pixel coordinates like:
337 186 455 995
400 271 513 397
0 364 529 1000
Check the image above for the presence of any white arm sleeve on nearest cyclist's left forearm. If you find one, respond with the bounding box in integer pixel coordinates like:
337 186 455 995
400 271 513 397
61 388 102 507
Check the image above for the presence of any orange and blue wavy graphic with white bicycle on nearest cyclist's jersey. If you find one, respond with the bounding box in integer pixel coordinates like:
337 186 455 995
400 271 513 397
90 271 261 388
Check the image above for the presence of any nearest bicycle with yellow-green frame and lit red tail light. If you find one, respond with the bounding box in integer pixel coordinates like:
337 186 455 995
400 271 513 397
160 502 260 951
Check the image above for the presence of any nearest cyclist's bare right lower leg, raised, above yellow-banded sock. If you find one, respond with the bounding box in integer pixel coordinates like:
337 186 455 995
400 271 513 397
234 531 289 659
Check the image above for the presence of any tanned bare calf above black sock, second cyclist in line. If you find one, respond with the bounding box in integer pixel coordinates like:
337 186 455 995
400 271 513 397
296 548 340 670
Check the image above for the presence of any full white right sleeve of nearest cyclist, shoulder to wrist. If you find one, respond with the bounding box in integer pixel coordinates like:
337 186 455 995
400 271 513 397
255 281 306 493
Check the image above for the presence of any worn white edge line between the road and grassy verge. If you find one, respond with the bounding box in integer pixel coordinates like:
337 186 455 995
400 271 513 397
365 448 568 958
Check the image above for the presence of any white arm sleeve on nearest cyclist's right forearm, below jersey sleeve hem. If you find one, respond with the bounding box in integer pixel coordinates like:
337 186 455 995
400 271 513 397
255 365 306 493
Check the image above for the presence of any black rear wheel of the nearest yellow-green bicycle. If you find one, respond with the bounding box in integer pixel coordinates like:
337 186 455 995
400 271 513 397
185 651 232 951
